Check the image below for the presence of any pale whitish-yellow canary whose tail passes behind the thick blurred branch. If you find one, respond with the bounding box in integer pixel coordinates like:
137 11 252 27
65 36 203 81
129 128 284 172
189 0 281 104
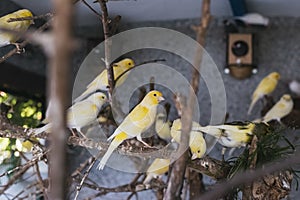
33 92 107 136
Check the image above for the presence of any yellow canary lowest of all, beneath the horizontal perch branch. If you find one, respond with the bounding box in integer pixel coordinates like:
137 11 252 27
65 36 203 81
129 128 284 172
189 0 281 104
143 158 171 184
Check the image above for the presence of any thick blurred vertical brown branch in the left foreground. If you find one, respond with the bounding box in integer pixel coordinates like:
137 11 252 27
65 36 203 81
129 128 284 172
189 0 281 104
48 0 73 199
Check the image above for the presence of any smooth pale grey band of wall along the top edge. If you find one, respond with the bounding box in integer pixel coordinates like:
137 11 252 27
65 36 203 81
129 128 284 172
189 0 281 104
13 0 300 25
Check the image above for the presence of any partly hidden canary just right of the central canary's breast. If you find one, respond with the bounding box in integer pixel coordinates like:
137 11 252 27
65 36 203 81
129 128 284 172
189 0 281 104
155 113 172 141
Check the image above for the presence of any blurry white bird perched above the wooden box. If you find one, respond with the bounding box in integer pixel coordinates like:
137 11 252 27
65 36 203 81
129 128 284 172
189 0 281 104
235 13 269 26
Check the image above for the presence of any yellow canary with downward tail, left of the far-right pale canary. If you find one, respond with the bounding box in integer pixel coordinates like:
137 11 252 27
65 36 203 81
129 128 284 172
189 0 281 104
248 72 280 115
